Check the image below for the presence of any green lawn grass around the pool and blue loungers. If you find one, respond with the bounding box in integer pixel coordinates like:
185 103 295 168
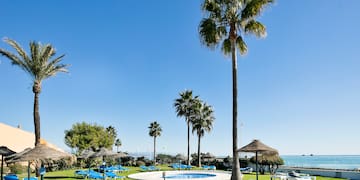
19 165 346 180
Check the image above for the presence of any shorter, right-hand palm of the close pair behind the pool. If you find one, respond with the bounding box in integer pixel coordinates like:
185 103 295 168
192 102 215 167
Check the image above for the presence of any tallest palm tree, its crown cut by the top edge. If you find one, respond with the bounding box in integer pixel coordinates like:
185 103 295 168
199 0 273 180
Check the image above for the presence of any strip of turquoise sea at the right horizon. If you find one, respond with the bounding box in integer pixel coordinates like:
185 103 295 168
281 155 360 170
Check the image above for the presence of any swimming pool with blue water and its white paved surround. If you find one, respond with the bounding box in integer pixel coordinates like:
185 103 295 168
128 170 231 180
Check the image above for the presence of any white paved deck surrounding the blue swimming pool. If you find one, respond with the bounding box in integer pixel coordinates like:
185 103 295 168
128 171 231 180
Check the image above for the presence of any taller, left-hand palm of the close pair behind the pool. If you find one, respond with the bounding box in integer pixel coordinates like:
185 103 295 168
174 90 199 165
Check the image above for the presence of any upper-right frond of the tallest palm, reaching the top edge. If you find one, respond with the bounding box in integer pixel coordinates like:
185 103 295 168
241 0 274 19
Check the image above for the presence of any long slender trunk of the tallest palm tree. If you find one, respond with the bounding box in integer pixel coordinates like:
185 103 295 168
230 34 242 180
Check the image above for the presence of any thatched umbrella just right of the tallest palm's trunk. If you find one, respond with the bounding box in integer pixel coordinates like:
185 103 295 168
237 139 278 180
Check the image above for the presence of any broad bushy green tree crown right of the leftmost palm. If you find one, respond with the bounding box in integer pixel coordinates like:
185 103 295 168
65 122 117 153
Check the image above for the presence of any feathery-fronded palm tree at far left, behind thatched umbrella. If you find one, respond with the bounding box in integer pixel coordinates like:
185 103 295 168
0 38 68 146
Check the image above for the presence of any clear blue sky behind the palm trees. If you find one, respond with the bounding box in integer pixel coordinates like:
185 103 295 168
0 0 360 155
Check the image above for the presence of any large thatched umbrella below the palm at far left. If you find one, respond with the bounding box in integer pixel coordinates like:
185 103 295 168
10 144 72 179
